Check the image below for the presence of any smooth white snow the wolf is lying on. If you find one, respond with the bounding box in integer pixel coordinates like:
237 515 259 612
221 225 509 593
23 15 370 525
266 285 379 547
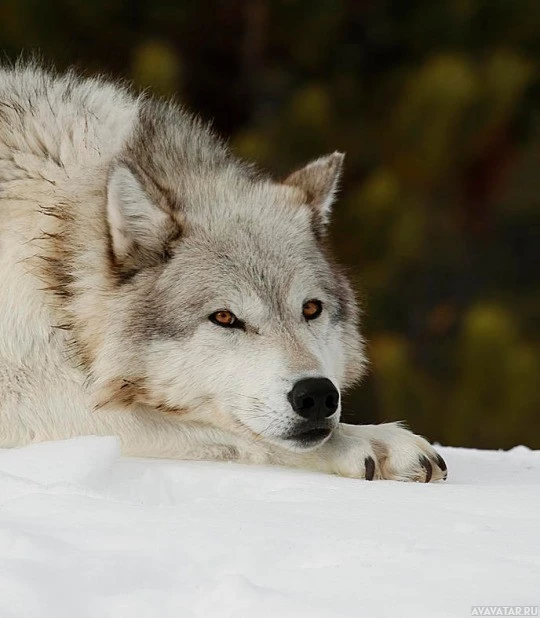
0 437 540 618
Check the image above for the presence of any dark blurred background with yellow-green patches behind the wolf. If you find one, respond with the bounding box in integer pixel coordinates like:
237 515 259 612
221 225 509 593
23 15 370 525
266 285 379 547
0 0 540 448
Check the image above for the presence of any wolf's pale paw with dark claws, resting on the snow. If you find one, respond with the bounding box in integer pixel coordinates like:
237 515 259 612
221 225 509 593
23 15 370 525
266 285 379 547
346 423 447 483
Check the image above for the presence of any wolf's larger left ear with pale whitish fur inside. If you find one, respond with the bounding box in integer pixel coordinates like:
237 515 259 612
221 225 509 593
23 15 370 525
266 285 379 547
107 164 180 272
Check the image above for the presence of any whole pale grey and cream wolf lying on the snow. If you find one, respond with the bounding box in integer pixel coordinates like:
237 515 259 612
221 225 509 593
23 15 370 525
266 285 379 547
0 63 446 481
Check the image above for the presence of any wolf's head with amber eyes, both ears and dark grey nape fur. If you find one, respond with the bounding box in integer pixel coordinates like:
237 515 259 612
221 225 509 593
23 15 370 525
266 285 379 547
93 101 364 449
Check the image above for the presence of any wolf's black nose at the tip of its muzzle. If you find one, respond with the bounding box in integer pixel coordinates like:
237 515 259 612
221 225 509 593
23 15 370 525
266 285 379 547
288 378 339 420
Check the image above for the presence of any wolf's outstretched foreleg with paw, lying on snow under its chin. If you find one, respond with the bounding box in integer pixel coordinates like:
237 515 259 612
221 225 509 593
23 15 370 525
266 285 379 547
94 413 446 482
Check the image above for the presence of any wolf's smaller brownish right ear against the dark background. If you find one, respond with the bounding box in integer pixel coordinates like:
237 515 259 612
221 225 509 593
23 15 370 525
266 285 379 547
283 152 345 227
